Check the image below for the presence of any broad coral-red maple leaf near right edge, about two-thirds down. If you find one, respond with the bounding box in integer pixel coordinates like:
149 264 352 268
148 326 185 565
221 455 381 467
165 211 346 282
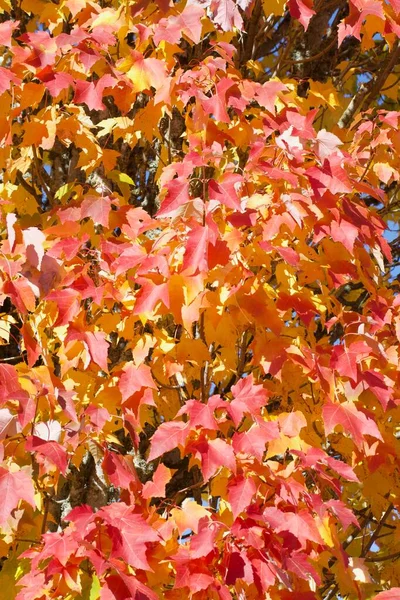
322 400 383 445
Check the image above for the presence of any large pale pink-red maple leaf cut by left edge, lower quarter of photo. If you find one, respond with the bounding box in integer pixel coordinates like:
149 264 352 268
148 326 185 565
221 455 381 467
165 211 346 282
0 467 35 525
